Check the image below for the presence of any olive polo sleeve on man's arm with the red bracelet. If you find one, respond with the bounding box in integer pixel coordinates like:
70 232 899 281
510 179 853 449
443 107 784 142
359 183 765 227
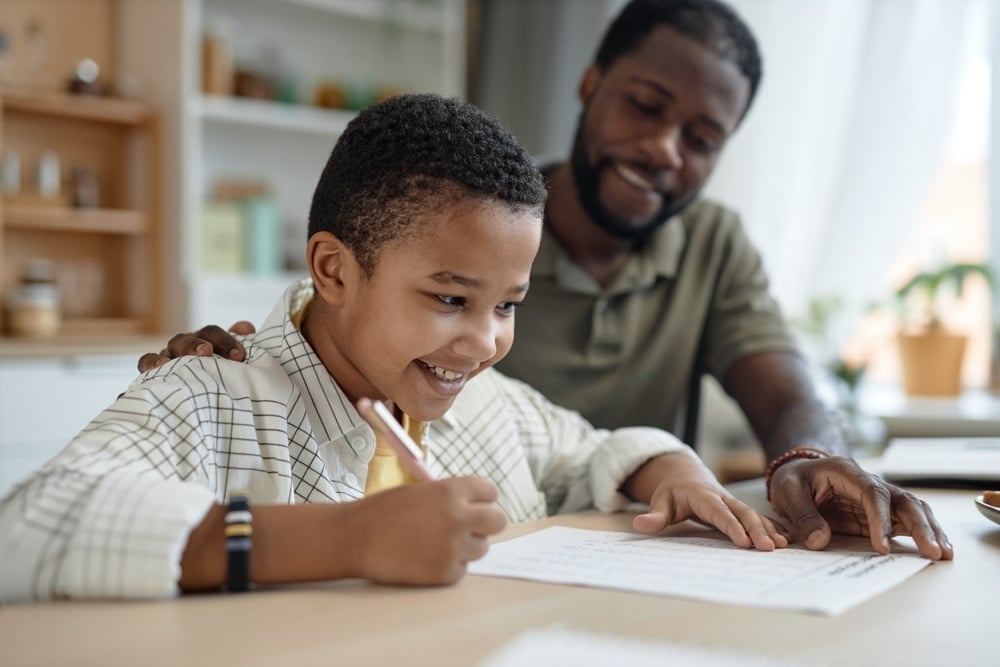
704 207 799 379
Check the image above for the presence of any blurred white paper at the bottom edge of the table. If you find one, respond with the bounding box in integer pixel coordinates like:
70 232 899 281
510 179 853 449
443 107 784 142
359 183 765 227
480 628 781 667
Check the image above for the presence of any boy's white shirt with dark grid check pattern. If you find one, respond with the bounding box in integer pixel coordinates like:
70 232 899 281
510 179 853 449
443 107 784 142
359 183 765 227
0 281 693 601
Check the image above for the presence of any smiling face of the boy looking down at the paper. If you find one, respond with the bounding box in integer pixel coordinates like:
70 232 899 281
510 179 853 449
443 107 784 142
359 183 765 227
314 202 541 421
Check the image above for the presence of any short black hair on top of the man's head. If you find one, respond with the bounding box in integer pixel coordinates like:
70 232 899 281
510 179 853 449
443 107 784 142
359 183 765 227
594 0 763 113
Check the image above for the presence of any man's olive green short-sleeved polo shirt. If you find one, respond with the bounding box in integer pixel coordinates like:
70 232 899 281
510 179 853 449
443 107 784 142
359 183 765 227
498 200 796 432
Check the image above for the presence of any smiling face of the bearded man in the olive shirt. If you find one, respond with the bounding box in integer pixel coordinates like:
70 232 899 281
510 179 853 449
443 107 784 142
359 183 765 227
571 26 750 239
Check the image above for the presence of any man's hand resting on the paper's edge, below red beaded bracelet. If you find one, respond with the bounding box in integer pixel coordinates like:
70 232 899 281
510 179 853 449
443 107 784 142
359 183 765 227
771 456 955 560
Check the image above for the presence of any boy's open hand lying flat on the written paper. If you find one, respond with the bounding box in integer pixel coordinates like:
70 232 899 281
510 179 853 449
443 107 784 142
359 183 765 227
629 454 788 551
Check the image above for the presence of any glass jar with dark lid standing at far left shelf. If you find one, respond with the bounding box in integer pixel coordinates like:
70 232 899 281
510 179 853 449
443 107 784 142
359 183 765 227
7 259 59 338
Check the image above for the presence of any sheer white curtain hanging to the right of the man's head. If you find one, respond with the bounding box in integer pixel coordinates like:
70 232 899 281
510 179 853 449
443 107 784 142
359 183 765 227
707 0 975 314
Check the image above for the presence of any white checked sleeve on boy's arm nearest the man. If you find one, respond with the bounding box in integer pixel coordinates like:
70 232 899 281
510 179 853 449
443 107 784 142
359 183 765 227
495 373 698 514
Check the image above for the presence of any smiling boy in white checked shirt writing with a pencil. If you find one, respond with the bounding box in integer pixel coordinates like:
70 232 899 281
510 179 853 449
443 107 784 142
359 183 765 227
0 95 786 601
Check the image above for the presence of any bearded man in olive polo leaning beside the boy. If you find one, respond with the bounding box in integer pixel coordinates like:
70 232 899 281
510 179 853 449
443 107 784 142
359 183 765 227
146 0 952 558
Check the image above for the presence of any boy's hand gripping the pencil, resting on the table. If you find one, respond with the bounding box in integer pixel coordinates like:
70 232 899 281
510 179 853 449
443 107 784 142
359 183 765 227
345 477 507 585
